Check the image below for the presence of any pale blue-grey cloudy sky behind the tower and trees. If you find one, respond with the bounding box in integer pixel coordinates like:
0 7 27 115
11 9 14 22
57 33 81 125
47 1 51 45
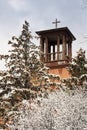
0 0 87 56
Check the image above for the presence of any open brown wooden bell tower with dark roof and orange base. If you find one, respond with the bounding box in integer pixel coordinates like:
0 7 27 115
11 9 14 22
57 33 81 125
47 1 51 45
36 20 76 78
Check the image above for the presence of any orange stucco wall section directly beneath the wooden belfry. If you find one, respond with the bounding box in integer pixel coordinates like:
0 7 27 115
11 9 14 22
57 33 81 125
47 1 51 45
49 68 70 78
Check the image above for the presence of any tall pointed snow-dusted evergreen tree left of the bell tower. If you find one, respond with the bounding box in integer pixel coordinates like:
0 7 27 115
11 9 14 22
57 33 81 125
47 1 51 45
0 21 59 112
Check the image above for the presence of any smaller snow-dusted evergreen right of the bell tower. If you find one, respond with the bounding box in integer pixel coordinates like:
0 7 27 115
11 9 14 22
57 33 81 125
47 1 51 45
63 49 87 90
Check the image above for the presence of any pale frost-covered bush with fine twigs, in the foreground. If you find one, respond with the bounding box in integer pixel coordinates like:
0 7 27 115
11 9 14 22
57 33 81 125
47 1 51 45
9 90 87 130
